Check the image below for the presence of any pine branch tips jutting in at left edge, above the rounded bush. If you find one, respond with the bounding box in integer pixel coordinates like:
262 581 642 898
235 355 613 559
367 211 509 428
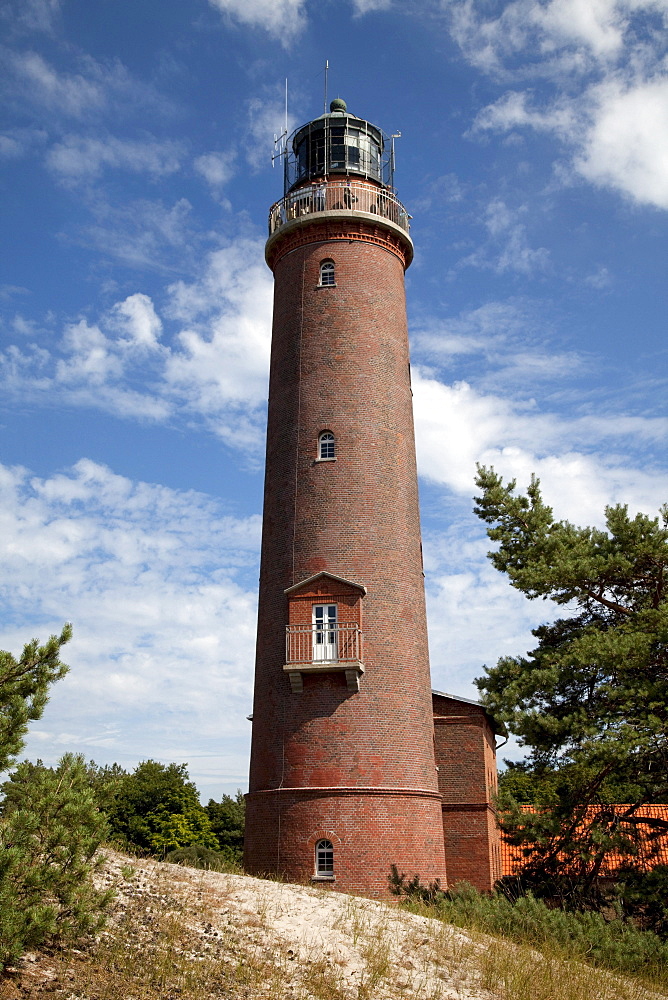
0 625 72 772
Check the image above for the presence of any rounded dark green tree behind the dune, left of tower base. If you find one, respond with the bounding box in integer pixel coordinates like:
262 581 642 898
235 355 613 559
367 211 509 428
102 760 218 855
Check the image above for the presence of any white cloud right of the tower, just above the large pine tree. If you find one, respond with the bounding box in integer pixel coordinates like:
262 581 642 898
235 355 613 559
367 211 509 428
413 370 668 523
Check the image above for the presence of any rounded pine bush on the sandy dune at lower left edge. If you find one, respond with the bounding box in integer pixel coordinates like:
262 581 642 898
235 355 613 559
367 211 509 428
0 754 109 968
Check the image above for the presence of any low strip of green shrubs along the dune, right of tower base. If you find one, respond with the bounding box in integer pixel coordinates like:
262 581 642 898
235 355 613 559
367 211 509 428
391 868 668 985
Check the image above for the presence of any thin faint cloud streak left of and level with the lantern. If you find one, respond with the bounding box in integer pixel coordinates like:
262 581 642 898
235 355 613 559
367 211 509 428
47 135 182 182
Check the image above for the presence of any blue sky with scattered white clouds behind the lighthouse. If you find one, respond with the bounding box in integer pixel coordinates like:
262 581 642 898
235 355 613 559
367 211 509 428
0 0 668 797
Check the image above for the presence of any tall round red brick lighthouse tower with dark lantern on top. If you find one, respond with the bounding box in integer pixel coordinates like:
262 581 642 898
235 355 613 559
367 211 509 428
245 100 445 897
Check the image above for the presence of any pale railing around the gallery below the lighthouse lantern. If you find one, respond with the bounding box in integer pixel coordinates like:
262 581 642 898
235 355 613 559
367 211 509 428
269 181 411 236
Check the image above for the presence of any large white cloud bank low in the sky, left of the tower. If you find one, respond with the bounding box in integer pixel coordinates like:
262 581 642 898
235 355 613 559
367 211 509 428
0 459 260 792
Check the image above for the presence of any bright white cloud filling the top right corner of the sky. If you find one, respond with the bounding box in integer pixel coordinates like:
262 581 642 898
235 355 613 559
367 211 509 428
462 0 668 209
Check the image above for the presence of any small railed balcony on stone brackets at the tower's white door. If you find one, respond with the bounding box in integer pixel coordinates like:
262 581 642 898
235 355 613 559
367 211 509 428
283 624 364 694
